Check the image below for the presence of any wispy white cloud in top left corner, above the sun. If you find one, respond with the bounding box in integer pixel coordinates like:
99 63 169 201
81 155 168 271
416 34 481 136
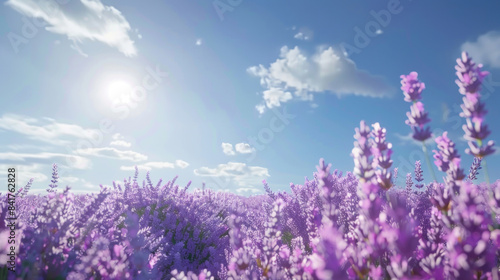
6 0 137 57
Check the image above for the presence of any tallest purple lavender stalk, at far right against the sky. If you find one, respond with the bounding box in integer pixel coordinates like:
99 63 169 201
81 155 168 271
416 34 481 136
455 52 495 185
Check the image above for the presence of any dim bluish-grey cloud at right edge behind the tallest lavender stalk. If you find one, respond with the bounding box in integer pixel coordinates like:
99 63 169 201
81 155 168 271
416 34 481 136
461 31 500 68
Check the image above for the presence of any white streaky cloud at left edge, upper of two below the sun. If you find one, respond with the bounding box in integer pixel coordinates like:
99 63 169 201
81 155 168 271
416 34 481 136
0 114 100 145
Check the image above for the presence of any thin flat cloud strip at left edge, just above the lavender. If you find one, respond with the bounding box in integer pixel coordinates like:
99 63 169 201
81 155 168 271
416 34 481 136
0 152 91 169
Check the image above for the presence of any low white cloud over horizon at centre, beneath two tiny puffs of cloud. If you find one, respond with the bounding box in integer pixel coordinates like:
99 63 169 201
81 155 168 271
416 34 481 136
194 162 270 192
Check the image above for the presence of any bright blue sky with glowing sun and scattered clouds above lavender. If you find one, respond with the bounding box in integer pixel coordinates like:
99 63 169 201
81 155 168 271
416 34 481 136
0 0 500 195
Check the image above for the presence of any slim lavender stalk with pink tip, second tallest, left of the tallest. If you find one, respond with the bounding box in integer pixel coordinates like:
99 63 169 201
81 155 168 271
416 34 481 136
400 72 437 181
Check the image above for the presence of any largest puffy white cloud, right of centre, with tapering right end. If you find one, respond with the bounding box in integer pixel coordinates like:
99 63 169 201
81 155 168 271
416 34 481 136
247 46 395 113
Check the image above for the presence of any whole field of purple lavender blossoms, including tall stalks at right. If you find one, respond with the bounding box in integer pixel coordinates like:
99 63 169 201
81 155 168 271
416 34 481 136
0 53 500 280
